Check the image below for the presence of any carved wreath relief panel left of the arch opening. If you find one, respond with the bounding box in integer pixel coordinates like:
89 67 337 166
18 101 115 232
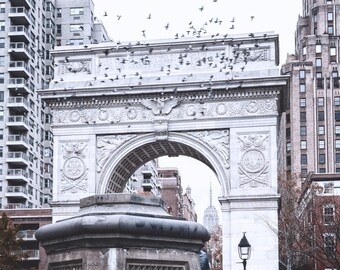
60 143 88 194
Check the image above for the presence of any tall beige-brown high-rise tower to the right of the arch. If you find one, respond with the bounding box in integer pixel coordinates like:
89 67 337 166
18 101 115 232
279 0 340 178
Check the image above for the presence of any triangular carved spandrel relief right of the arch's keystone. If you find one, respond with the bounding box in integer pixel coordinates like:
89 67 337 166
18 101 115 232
189 130 230 169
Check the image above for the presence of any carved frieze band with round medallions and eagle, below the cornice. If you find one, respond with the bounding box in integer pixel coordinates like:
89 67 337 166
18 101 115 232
52 98 277 124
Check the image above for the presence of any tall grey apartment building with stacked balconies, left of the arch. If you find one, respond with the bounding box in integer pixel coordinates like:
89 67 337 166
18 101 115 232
0 0 108 209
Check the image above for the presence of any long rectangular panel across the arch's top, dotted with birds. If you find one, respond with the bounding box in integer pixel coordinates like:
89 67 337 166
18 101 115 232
98 46 270 74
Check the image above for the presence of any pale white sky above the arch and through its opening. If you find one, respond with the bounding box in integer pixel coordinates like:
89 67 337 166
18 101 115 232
93 0 302 222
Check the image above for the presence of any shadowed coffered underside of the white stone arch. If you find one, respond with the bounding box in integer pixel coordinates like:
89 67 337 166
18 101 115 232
105 140 216 193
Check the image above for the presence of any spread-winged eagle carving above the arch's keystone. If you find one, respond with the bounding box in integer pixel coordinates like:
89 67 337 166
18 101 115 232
142 97 180 115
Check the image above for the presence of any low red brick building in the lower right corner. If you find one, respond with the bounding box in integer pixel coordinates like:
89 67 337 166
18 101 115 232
298 173 340 270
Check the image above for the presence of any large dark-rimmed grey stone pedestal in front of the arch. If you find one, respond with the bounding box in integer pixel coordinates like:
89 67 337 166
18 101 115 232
36 194 210 270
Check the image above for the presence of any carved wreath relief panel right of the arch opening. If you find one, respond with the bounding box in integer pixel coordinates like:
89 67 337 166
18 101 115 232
238 134 269 188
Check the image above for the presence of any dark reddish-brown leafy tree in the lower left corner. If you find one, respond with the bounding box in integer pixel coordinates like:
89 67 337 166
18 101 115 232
0 213 27 270
